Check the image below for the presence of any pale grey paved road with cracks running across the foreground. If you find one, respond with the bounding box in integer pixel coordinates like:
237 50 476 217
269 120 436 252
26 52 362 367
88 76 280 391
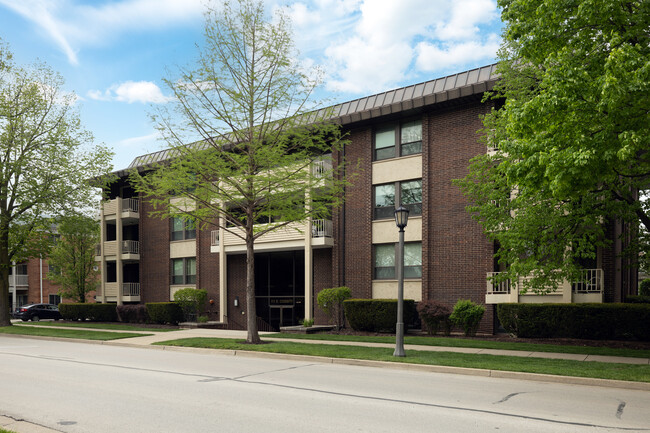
0 336 650 433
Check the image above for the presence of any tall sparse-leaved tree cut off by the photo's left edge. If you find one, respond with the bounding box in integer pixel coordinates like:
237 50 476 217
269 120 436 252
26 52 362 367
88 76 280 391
0 43 111 326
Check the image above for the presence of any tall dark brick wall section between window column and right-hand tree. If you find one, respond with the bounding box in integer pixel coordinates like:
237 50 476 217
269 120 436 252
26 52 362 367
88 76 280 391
423 102 493 332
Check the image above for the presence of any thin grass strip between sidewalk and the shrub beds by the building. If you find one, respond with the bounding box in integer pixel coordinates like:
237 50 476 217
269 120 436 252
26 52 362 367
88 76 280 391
264 333 650 358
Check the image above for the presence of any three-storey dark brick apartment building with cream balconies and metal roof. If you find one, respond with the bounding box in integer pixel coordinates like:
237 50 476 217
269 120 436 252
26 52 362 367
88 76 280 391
96 65 636 332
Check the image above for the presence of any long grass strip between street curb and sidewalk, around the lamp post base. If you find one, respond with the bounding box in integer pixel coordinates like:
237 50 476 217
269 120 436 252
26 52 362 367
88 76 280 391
154 338 650 382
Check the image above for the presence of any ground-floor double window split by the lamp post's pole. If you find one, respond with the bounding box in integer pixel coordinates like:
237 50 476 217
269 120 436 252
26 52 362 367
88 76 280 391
374 242 422 280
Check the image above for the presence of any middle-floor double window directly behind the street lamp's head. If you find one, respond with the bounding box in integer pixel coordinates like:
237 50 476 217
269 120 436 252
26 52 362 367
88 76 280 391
374 179 422 219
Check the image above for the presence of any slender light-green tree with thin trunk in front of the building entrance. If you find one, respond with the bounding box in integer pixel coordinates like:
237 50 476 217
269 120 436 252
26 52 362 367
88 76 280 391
131 0 345 343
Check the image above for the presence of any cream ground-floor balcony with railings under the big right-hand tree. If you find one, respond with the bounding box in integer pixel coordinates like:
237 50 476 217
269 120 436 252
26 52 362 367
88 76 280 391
485 269 604 304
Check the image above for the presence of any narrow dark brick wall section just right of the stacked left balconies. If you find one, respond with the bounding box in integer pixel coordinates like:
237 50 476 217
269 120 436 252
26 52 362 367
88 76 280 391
140 200 171 303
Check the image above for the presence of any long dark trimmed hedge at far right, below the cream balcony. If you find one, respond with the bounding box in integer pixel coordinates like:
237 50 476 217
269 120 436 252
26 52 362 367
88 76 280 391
497 304 650 341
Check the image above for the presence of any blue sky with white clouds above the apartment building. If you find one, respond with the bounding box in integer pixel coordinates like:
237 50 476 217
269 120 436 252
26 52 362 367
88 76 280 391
0 0 502 169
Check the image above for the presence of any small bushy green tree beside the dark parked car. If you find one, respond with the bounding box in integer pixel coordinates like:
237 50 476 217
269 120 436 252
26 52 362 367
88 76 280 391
48 215 99 303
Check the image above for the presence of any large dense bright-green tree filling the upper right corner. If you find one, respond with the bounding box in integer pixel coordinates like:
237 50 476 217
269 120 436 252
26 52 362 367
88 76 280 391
459 0 650 292
